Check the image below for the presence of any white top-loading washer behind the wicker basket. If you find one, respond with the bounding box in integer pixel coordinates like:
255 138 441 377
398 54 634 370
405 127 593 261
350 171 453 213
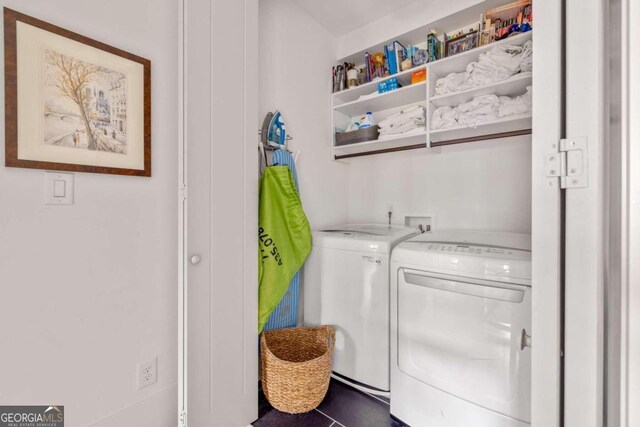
303 224 417 391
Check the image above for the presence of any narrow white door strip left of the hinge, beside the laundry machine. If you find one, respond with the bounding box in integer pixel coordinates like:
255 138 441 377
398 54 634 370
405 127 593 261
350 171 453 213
531 0 564 427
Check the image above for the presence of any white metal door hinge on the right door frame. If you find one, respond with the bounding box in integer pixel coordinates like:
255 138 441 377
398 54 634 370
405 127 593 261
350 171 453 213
545 137 589 189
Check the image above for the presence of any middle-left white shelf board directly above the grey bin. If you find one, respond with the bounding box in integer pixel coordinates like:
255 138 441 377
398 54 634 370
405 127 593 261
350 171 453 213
333 82 427 117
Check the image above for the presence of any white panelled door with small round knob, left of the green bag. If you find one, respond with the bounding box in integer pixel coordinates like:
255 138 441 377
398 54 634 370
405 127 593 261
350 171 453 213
180 0 258 427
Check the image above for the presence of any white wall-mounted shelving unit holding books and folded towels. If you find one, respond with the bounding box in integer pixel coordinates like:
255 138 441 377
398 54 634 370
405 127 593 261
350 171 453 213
331 0 533 159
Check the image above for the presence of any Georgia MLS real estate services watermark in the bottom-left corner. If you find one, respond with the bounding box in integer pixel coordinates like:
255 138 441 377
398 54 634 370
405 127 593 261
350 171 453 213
0 405 64 427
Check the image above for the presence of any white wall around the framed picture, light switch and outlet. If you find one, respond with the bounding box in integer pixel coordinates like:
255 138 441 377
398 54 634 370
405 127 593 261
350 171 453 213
0 0 178 427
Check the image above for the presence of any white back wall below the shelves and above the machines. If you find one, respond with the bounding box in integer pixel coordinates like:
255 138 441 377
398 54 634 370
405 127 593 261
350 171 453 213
349 136 531 233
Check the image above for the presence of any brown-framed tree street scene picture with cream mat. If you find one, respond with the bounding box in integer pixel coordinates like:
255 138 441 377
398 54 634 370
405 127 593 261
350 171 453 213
4 8 151 176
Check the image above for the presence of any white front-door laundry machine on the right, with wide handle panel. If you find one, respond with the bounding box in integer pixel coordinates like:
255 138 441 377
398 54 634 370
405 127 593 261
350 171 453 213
391 231 531 427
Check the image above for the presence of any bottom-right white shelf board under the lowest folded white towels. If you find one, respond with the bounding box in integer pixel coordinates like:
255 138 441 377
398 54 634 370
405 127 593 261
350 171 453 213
429 114 531 146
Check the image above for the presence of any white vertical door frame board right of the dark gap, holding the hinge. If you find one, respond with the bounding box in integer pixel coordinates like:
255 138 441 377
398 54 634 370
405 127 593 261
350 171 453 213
564 0 609 427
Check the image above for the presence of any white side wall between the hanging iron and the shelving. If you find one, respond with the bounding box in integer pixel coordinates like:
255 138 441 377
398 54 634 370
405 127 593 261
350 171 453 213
257 0 349 229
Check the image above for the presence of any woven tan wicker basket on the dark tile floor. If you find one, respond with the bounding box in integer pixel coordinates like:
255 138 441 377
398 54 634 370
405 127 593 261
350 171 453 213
260 326 335 414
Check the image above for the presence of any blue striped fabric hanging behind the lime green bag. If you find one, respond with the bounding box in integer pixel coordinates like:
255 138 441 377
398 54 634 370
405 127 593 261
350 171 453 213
264 150 300 331
